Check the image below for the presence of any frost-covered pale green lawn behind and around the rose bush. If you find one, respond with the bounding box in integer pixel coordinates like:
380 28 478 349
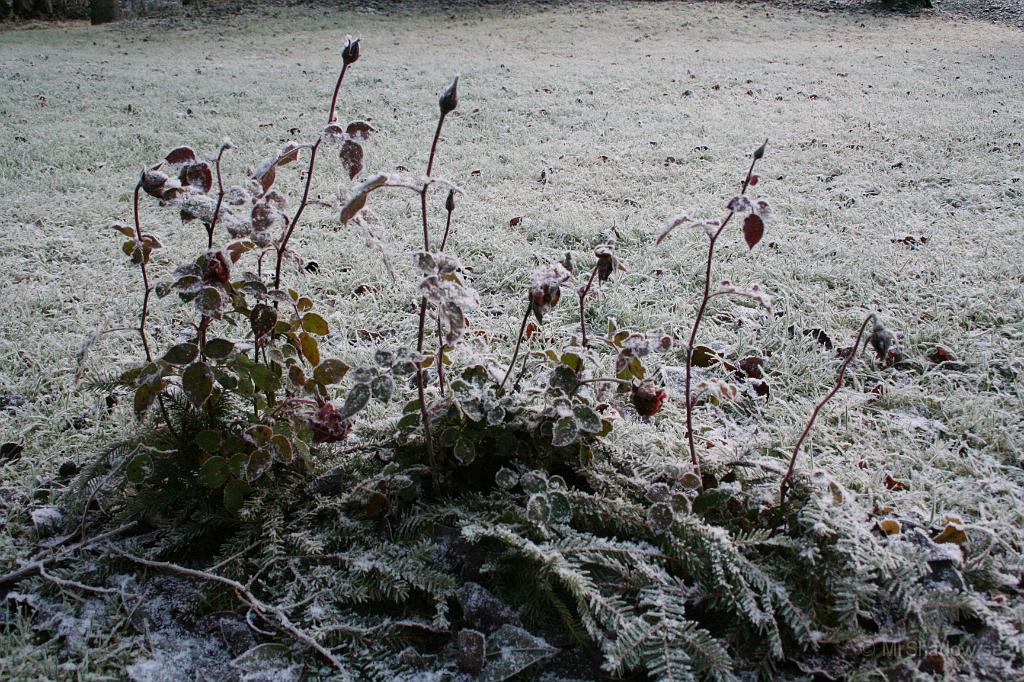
0 4 1024 677
